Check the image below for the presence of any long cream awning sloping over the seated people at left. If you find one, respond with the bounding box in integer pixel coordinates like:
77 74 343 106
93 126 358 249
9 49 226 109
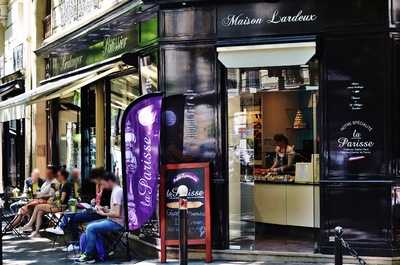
0 62 123 121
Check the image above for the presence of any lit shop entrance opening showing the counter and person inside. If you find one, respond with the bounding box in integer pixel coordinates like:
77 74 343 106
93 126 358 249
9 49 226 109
227 45 319 252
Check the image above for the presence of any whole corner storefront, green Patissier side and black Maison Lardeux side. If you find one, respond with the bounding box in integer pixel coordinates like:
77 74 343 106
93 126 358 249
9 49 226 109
0 0 400 256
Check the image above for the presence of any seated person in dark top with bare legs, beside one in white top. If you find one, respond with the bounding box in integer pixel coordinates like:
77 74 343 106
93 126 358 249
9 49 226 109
22 169 72 237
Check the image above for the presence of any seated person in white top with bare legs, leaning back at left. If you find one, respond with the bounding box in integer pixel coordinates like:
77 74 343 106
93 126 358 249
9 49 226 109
9 165 57 229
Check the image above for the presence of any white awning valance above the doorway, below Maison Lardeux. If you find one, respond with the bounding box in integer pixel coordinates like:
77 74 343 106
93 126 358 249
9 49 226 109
217 42 316 68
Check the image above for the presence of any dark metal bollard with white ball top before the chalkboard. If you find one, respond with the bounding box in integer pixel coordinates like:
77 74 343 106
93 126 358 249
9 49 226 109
178 185 188 265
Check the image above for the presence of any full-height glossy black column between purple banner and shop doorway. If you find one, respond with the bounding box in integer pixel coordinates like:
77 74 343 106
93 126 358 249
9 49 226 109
160 6 228 248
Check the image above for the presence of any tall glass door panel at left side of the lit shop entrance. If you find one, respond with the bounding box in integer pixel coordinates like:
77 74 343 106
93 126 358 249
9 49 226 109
227 69 262 249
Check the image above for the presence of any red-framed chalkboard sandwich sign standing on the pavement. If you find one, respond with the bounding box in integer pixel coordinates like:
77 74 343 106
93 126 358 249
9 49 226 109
160 163 212 262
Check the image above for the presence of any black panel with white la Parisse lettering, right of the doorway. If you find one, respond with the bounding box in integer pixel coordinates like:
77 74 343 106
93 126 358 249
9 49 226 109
323 34 386 176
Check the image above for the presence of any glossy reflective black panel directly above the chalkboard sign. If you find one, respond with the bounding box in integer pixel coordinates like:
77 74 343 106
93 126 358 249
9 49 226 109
162 46 218 163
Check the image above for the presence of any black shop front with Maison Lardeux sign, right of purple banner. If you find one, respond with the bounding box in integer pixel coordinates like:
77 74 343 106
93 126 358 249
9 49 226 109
150 0 400 256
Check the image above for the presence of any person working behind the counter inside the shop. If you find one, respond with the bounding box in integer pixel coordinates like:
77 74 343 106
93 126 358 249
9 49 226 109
268 134 295 174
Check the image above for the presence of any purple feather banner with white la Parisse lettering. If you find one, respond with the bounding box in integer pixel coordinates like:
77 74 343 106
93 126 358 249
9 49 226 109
122 93 162 230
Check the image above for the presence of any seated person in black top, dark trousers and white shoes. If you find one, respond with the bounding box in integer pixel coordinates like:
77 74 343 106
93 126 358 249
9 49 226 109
46 168 111 244
